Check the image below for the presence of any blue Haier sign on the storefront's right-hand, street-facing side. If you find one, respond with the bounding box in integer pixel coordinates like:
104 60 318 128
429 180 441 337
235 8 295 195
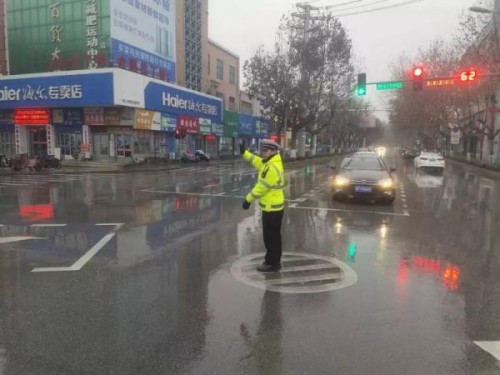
144 82 222 123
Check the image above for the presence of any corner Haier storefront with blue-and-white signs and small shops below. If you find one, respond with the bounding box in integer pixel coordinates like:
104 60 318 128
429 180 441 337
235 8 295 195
0 68 222 160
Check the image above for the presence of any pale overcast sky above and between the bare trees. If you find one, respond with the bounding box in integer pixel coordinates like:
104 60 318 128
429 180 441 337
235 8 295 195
209 0 491 117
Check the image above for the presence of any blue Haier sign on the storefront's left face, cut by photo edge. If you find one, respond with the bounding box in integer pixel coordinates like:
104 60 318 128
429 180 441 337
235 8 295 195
0 72 114 109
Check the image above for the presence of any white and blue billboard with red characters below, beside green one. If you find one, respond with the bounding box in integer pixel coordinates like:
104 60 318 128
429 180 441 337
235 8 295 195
110 0 176 82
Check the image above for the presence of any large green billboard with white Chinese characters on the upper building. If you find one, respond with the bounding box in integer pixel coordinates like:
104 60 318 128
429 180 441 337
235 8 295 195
5 0 110 74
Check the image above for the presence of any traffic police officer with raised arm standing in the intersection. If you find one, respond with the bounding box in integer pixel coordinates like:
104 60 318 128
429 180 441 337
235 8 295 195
240 139 285 272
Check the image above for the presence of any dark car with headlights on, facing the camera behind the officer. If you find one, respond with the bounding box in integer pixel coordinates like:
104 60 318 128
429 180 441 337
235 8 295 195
332 154 396 204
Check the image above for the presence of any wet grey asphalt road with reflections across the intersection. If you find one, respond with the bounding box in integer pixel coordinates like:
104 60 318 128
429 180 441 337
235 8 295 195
0 153 500 375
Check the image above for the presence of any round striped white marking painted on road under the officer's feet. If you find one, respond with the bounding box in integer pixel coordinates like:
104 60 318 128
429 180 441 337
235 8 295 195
231 253 358 293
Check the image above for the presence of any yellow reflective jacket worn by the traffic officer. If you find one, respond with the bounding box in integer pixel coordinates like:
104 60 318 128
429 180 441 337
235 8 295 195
243 150 285 212
